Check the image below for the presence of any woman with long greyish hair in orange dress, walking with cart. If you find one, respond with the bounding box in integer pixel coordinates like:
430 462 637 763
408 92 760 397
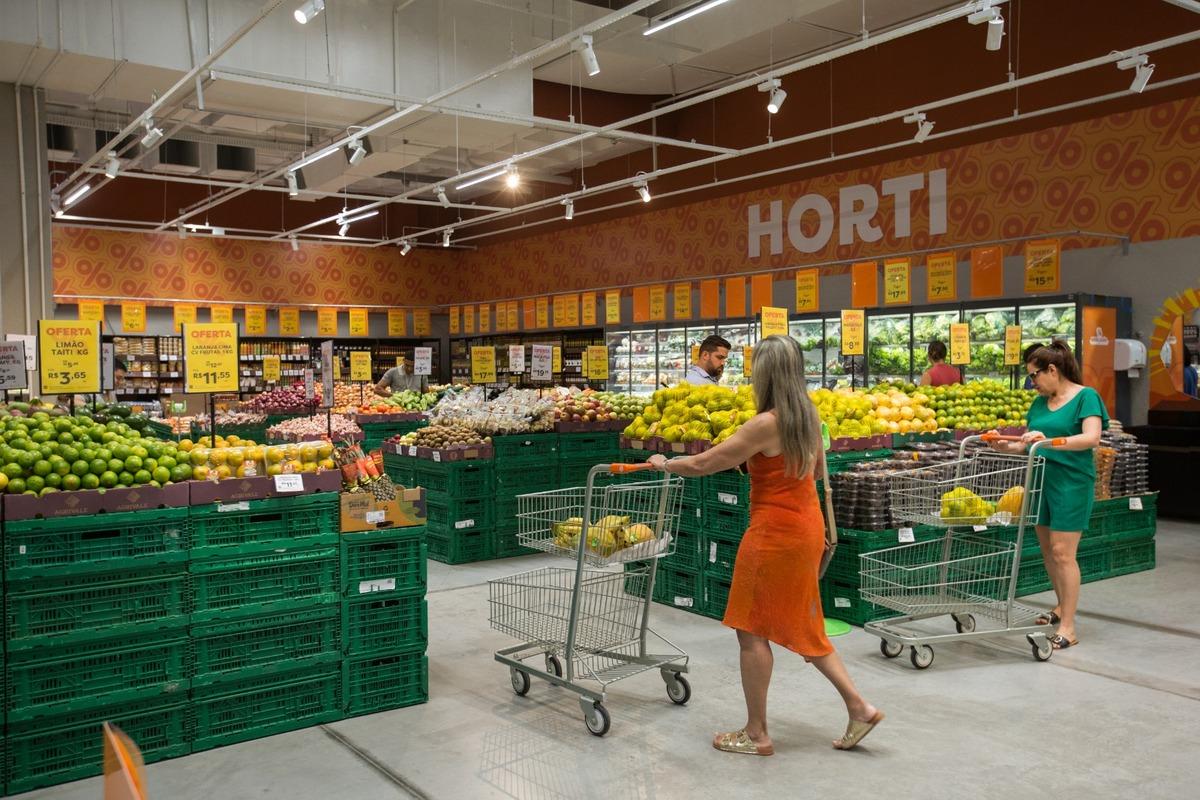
650 336 883 756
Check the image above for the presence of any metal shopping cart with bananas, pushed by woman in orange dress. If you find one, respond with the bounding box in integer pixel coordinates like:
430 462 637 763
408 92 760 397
488 464 691 736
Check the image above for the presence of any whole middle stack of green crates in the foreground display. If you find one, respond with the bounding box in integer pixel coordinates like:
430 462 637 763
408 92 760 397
188 493 344 751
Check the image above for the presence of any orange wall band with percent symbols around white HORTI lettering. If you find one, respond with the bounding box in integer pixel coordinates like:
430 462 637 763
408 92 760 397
54 97 1200 306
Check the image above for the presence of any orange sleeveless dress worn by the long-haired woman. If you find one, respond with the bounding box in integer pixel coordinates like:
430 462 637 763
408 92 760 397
724 453 833 657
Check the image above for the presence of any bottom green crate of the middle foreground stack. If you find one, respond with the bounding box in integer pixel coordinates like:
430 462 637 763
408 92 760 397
191 666 344 752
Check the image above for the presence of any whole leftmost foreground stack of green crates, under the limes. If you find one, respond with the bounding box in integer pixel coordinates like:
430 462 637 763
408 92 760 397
0 507 192 793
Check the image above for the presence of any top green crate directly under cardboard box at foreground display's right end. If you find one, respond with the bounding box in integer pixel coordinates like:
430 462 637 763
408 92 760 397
342 525 428 597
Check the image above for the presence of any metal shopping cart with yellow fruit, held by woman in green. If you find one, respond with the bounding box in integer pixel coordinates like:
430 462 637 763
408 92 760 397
859 433 1064 669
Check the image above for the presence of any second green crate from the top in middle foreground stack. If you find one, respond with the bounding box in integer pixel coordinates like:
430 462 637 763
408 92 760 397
190 547 342 625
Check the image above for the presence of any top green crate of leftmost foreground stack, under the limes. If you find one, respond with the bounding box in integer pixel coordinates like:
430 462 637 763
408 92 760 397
4 507 191 581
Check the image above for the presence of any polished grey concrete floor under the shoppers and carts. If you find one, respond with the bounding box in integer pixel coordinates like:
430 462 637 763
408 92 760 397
22 521 1200 800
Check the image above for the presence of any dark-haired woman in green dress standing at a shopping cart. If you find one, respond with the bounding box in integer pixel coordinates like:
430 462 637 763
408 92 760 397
992 342 1109 650
